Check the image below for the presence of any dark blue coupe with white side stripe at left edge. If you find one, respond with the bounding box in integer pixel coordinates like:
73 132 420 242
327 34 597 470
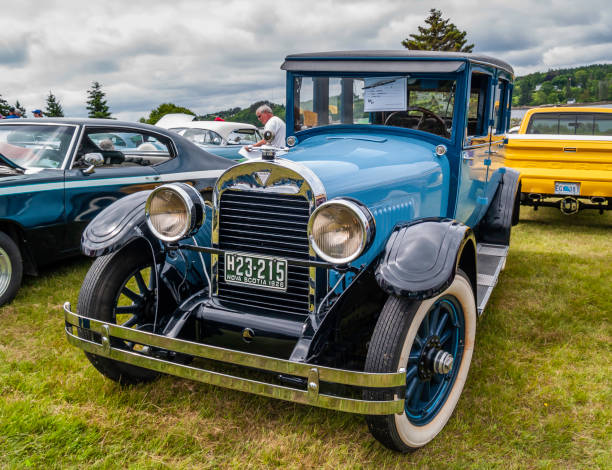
0 119 232 305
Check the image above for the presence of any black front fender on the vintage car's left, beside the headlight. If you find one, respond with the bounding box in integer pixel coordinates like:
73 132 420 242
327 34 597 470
81 191 161 257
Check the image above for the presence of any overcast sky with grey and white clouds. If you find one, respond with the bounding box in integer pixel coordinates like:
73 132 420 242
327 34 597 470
0 0 612 120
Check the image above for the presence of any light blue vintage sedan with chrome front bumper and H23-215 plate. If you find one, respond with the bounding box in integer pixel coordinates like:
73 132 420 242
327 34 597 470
64 50 520 452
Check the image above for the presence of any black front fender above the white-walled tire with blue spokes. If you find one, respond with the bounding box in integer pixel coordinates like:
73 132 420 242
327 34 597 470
376 218 476 299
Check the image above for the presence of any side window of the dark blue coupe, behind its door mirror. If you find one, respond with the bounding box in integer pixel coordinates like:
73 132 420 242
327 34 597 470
75 128 172 168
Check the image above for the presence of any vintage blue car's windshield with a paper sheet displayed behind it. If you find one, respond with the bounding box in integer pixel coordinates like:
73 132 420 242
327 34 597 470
294 75 456 138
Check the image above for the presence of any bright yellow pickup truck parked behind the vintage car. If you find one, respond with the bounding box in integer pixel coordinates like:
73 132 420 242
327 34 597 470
506 107 612 214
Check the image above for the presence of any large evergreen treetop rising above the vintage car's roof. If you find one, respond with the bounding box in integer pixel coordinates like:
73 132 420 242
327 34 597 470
402 8 474 52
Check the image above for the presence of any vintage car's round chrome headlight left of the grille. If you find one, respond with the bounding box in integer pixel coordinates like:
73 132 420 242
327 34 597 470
145 183 205 242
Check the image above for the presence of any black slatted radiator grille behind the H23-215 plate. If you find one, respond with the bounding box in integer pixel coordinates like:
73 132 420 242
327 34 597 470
218 190 310 315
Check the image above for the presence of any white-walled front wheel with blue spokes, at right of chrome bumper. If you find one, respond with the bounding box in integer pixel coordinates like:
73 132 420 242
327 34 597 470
365 270 476 452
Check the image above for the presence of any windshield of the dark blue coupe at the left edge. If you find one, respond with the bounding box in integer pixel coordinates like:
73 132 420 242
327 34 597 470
0 124 76 168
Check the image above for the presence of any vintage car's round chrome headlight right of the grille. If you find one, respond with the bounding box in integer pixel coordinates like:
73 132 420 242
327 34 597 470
308 199 375 265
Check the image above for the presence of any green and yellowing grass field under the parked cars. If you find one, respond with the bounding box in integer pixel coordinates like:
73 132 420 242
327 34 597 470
0 209 612 469
